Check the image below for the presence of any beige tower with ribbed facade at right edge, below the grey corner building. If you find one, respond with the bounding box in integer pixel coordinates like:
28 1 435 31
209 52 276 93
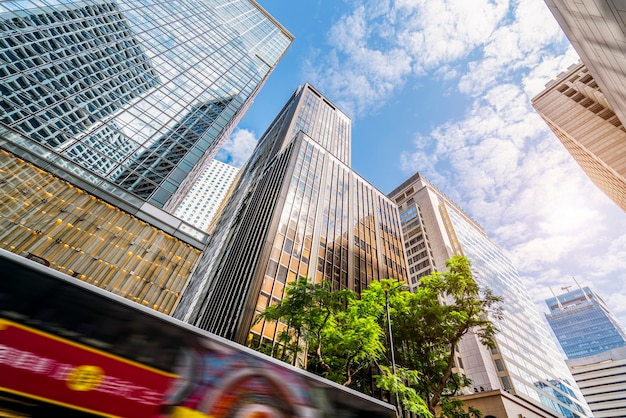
532 63 626 211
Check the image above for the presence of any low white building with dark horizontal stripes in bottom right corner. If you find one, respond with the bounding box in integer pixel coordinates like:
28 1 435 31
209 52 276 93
566 346 626 418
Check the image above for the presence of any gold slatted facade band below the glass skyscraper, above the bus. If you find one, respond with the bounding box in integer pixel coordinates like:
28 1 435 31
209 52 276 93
0 149 200 314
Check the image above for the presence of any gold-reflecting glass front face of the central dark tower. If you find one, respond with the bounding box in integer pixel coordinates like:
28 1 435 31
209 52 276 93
246 134 407 347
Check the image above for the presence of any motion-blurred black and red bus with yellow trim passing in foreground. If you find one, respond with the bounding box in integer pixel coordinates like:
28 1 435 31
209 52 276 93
0 250 396 418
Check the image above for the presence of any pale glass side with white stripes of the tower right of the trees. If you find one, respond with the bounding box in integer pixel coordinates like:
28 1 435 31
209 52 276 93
445 206 591 418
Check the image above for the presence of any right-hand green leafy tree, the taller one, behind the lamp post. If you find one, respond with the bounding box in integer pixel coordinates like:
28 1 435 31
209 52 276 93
382 256 502 417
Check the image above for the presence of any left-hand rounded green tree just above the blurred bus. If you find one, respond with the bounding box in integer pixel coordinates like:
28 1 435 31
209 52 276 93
258 277 385 386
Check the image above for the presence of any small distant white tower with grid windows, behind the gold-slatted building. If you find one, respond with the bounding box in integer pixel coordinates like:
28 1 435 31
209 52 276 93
174 160 239 231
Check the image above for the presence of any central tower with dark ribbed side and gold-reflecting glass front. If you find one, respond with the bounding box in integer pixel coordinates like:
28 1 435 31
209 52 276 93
175 84 407 347
